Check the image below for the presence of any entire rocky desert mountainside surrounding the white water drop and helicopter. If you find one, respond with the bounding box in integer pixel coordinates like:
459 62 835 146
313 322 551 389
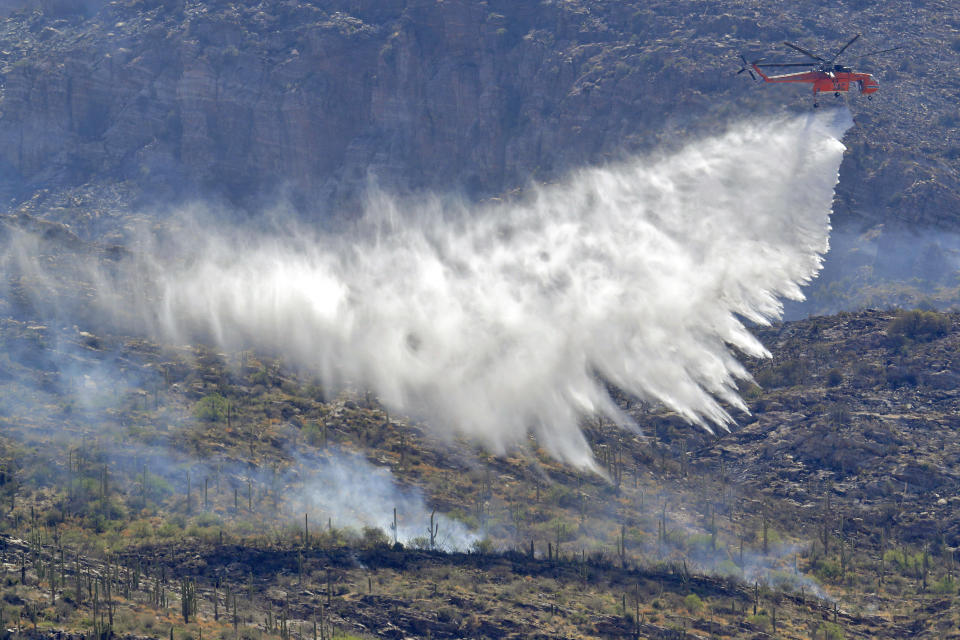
0 0 960 640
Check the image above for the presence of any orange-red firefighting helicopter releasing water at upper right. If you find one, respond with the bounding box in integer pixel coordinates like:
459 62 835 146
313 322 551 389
737 33 903 108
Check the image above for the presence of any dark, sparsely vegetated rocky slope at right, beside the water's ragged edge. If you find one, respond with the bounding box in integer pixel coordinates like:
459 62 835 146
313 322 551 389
710 312 960 546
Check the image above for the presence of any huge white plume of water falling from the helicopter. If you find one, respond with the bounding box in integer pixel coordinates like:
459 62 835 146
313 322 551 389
7 111 851 466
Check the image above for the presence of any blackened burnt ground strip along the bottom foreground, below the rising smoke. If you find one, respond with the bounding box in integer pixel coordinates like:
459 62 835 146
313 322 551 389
0 536 906 639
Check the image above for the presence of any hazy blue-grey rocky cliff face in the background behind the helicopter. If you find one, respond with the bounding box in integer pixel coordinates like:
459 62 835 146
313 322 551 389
0 0 960 300
